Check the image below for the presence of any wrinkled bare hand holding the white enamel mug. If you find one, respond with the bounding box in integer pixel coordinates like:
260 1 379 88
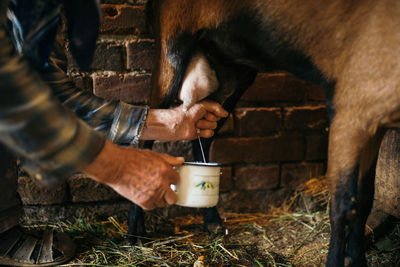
84 141 184 210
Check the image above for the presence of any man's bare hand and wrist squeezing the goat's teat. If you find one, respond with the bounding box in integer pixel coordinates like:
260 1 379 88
141 101 228 141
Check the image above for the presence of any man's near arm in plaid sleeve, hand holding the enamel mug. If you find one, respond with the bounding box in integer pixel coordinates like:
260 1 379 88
0 27 183 209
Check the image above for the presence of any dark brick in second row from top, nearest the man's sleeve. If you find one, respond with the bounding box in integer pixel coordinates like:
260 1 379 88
91 42 125 71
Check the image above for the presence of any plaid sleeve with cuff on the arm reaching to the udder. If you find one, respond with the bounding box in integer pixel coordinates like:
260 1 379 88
41 57 148 145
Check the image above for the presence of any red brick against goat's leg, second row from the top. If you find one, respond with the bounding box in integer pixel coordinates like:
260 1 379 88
126 39 155 70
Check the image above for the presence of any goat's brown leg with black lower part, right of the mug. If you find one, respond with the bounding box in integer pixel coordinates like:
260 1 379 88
326 115 383 266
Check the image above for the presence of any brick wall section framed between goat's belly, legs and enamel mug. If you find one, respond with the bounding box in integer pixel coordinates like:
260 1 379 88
211 71 328 211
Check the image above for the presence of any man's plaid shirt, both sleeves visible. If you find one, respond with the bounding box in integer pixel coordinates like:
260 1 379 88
0 4 148 184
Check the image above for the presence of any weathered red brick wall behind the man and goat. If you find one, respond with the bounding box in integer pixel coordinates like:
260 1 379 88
19 0 328 221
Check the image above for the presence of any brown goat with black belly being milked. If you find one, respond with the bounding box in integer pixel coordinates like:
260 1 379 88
139 0 400 266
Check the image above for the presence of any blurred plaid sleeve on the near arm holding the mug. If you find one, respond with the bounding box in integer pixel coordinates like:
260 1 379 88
0 28 105 184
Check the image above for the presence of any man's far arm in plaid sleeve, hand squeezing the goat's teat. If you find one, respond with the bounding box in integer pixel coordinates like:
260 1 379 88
41 56 228 144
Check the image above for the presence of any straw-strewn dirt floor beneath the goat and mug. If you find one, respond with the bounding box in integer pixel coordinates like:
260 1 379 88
24 179 400 267
